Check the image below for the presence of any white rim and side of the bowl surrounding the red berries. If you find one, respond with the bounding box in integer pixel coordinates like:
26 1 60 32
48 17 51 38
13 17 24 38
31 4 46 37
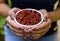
14 9 44 29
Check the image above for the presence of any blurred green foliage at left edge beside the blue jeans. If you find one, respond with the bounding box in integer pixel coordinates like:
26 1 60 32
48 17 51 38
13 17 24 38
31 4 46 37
0 15 5 41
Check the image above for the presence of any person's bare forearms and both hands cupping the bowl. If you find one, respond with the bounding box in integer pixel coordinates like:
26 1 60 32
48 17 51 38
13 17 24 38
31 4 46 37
0 0 60 39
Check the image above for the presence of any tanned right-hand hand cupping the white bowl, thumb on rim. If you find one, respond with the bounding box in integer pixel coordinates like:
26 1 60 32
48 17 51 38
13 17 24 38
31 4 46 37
30 9 51 39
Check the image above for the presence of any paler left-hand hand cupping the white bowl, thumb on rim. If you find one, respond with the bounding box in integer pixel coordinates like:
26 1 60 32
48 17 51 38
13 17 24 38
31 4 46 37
6 8 24 38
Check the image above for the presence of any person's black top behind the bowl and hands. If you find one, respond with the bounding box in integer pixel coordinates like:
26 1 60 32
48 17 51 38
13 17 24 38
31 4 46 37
6 0 57 35
